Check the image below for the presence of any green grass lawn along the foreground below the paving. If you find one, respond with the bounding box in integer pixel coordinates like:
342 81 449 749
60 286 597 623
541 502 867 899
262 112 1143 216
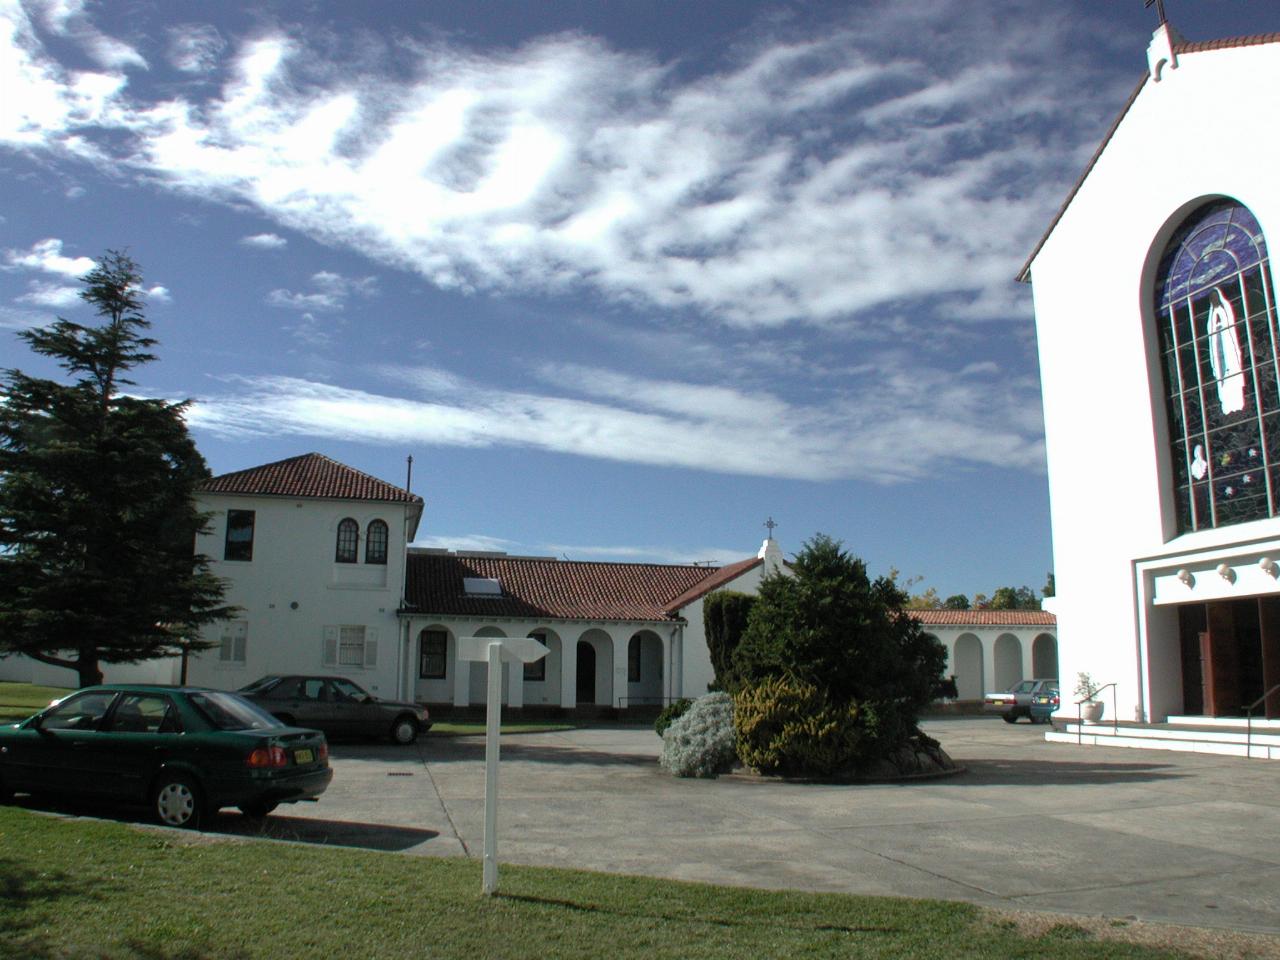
0 808 1203 960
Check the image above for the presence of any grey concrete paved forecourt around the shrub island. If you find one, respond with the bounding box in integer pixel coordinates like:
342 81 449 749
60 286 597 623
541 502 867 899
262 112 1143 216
204 717 1280 933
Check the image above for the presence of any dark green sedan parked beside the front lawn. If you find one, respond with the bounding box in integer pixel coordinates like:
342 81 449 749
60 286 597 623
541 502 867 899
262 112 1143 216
0 684 333 827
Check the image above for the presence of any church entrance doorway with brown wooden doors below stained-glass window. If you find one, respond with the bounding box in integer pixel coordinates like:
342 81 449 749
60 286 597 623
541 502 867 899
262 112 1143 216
1178 596 1280 717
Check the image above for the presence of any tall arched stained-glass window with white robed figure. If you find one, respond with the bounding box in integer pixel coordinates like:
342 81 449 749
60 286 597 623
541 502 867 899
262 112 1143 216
1155 200 1280 532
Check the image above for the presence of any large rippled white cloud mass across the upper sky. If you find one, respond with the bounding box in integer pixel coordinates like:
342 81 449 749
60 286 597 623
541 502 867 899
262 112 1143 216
0 0 1114 328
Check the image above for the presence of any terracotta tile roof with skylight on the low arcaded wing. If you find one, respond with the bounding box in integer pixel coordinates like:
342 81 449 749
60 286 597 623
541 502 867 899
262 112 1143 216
404 552 755 621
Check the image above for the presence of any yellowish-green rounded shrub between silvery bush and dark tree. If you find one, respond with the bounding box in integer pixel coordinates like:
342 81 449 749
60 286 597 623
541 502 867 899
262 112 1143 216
733 677 865 776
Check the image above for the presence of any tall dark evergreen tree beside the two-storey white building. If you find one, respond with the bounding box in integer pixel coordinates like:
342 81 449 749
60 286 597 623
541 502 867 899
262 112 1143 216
0 251 233 686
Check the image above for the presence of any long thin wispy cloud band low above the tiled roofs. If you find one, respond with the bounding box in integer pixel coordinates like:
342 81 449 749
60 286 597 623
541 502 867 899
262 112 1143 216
191 358 1043 483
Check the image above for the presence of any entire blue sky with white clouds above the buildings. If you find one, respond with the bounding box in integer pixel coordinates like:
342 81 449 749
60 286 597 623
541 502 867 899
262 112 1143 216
0 0 1280 596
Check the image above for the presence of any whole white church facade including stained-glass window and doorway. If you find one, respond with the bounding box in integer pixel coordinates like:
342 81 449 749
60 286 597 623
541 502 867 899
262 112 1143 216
1019 24 1280 723
